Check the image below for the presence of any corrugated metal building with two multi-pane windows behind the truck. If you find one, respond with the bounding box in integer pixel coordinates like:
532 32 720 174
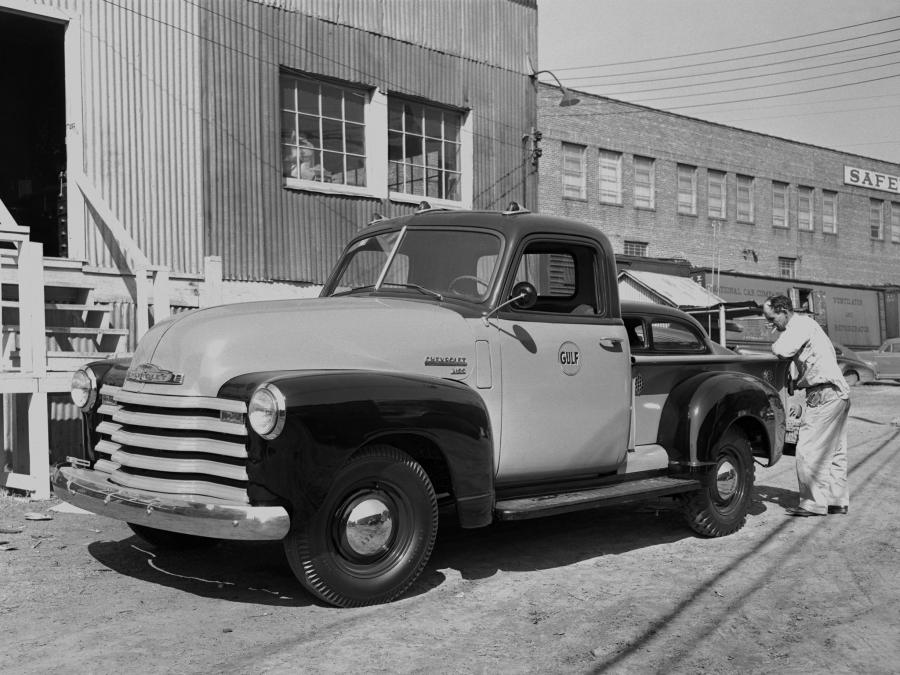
0 0 537 284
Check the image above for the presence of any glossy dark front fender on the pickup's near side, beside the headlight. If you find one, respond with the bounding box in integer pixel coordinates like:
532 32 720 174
219 370 494 527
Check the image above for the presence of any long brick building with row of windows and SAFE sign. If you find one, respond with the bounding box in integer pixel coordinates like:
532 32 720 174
528 84 900 346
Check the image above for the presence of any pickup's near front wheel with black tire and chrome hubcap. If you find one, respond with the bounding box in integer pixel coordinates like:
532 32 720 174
284 445 438 607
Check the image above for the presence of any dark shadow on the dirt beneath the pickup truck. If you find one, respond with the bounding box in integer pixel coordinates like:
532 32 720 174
88 485 796 607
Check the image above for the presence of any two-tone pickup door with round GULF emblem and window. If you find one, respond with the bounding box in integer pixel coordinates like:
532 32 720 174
492 238 631 483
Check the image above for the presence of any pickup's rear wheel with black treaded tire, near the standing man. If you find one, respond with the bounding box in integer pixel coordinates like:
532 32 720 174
683 429 756 537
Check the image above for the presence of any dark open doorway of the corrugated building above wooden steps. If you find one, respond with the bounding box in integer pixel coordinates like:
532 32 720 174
0 9 68 257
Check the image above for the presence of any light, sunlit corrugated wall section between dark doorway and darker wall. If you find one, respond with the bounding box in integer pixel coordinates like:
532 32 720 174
36 0 203 273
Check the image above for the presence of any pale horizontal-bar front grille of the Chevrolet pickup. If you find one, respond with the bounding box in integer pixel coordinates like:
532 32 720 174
94 385 248 503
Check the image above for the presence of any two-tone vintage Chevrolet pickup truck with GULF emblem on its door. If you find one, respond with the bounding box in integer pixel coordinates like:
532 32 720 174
53 206 787 606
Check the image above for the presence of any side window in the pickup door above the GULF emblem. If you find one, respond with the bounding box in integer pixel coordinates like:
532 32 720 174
513 242 603 315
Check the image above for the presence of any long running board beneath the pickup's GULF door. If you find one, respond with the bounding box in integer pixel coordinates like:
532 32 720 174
494 476 701 520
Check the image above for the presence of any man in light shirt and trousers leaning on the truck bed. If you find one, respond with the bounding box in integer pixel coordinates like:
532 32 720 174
763 295 850 517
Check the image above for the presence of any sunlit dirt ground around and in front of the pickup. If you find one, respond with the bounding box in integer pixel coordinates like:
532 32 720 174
0 384 900 674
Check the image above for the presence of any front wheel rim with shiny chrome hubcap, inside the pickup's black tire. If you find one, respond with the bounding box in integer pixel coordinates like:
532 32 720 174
335 489 397 564
